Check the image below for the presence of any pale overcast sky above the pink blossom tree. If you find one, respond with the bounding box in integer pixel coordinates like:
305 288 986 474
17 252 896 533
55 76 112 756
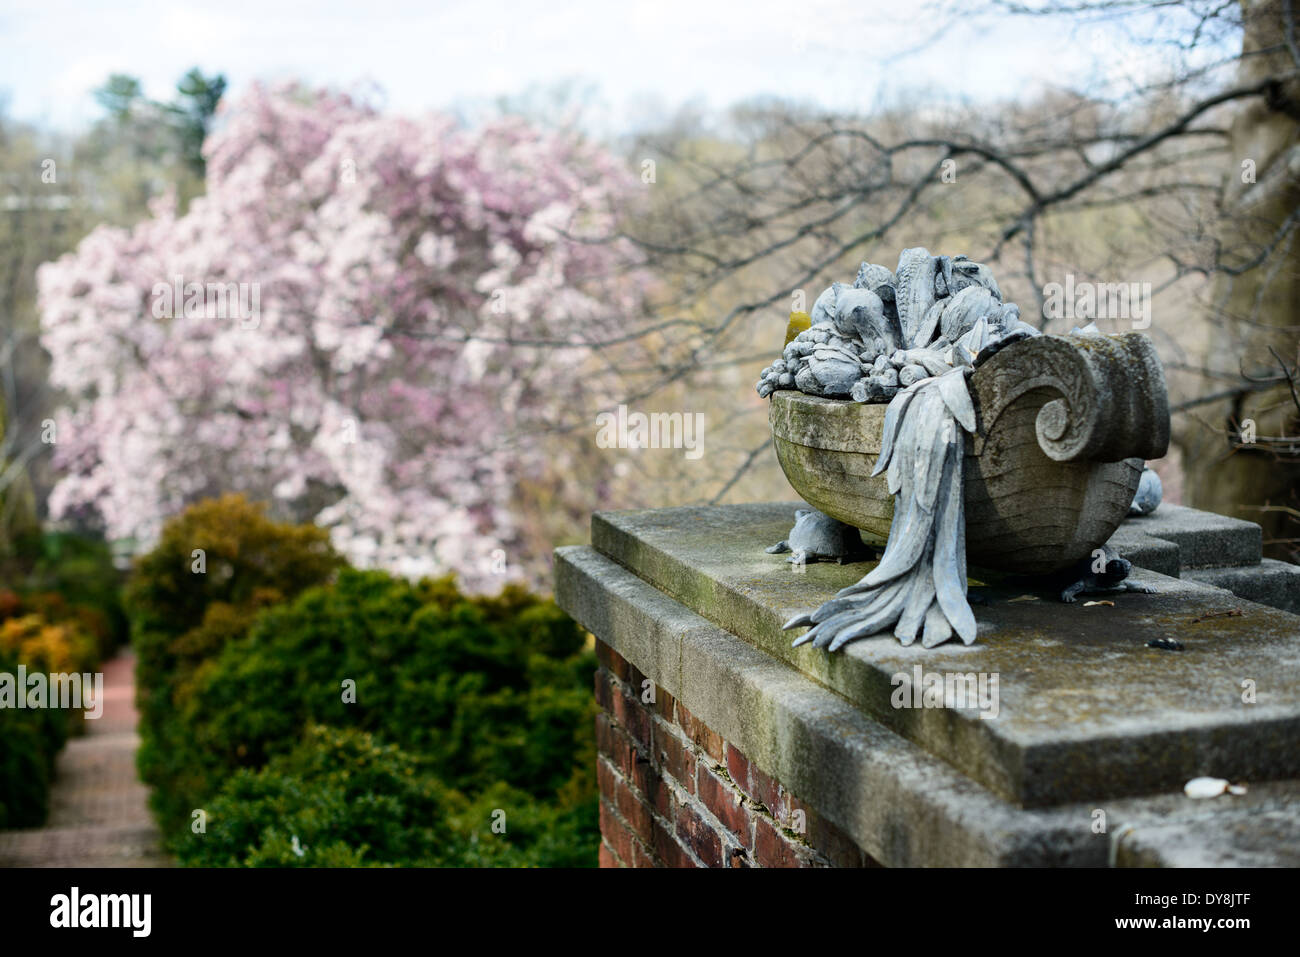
0 0 1216 131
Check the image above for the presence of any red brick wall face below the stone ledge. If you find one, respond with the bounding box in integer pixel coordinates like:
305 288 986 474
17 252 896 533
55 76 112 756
595 640 876 867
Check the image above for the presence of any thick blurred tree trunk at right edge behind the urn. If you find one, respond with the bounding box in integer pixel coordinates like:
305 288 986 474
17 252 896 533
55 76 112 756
1178 0 1300 558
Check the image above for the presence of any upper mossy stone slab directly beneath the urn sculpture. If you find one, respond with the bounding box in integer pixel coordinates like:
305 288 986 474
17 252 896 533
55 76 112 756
592 503 1300 806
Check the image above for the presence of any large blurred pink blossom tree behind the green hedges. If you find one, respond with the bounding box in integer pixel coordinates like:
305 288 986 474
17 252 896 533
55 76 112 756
39 86 640 588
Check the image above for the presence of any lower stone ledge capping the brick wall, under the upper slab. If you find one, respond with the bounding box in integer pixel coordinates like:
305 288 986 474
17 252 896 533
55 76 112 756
555 546 1300 867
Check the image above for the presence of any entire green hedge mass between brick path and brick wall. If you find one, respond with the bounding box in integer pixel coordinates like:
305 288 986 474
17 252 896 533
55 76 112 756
130 503 599 866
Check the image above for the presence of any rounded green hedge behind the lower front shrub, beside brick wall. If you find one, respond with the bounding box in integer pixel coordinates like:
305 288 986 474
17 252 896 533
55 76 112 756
165 570 595 863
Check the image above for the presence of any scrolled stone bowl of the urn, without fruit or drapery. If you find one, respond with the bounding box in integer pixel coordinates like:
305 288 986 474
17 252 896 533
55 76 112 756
768 333 1169 575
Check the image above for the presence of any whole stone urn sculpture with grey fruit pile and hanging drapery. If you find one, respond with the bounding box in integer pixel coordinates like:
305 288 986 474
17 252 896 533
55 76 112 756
755 246 1169 651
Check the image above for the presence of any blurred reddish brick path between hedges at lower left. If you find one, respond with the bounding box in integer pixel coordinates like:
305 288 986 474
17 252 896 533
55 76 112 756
0 653 172 867
